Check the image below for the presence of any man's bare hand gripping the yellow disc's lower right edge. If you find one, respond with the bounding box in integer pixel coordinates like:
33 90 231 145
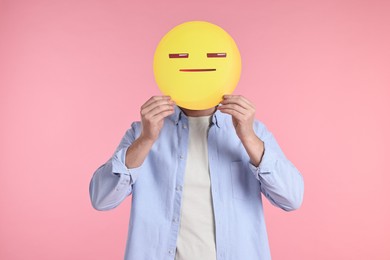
218 95 256 141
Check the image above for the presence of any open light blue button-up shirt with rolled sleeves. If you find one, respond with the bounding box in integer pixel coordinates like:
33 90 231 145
89 107 304 260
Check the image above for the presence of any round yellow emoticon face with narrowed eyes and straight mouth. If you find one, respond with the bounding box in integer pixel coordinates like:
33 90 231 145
153 21 241 110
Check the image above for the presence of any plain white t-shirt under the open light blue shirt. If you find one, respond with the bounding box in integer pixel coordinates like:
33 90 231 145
175 116 216 260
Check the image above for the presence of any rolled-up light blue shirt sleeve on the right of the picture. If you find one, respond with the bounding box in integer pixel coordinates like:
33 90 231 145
249 122 304 211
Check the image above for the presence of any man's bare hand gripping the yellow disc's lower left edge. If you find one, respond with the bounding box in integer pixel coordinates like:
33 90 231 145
140 96 175 142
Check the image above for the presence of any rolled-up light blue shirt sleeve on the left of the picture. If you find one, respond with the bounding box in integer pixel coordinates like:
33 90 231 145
89 122 142 210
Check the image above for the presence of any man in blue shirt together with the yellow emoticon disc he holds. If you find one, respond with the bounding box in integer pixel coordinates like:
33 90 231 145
90 21 304 260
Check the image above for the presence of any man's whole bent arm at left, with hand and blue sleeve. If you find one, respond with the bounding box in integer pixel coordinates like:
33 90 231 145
89 96 174 210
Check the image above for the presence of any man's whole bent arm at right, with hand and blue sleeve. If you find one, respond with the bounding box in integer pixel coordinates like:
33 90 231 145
218 95 304 211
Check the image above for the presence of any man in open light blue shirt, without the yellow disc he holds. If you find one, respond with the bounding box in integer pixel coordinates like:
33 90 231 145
90 95 303 260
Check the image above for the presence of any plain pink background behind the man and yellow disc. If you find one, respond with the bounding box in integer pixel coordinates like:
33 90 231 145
0 0 390 260
